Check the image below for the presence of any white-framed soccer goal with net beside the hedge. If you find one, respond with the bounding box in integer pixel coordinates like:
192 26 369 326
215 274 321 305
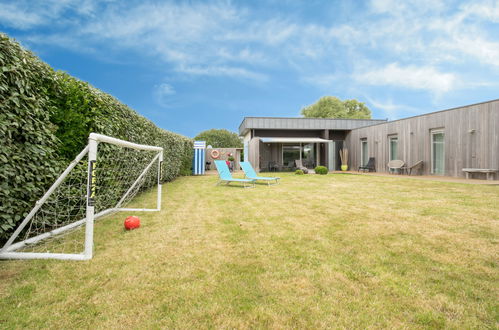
0 133 163 260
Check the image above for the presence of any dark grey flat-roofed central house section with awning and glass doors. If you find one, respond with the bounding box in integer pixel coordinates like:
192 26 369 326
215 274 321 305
239 117 386 170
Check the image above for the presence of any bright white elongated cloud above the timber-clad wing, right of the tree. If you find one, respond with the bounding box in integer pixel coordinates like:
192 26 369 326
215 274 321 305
353 63 458 93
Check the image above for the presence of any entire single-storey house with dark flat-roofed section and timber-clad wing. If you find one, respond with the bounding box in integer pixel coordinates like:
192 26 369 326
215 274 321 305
239 100 499 180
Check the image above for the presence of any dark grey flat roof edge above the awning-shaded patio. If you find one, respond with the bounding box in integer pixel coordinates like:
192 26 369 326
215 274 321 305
239 117 387 136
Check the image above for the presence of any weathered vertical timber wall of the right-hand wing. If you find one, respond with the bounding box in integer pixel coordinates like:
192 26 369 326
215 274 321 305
346 100 499 180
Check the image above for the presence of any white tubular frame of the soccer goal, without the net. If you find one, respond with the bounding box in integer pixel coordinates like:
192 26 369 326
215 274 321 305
0 133 163 260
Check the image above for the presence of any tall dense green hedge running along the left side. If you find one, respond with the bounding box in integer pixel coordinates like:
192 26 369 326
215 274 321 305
0 33 192 243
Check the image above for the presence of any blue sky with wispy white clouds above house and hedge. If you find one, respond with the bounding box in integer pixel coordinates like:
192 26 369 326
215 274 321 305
0 0 499 137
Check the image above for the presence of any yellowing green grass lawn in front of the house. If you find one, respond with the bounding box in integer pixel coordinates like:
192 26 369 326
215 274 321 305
0 174 499 329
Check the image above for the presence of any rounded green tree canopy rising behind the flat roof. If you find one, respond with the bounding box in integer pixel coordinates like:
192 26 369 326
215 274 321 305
301 96 371 119
